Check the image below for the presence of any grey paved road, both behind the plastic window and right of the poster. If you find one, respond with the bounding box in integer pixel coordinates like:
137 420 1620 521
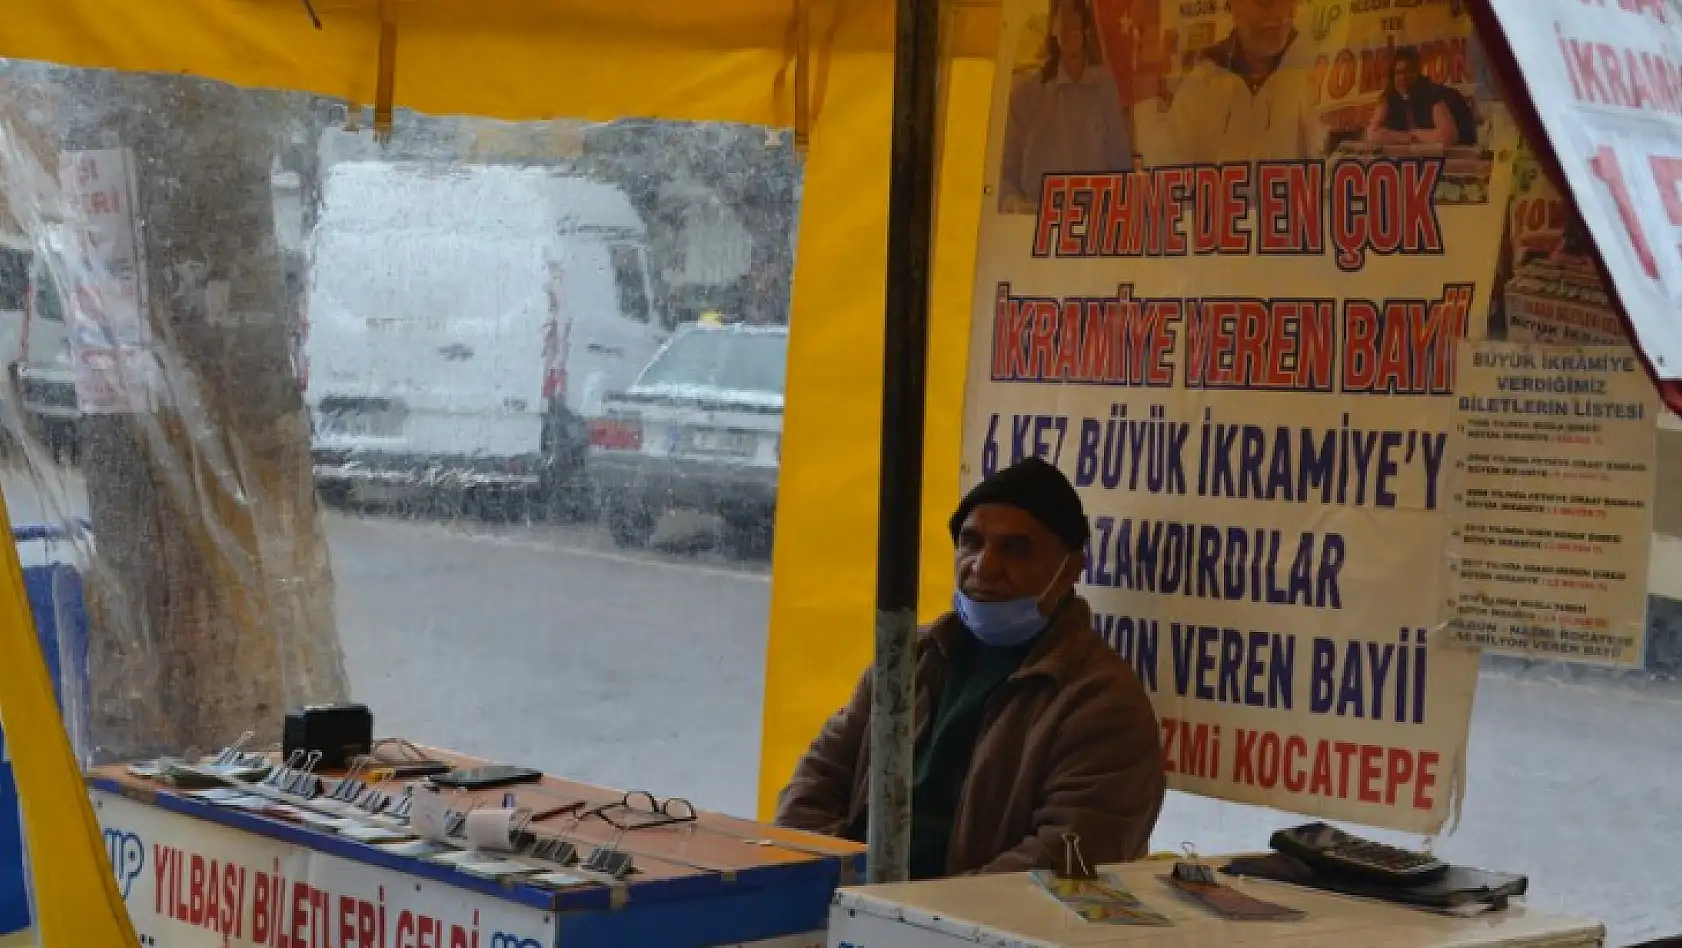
7 470 1682 945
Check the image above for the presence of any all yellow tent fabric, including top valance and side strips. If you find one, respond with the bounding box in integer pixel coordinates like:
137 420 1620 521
0 0 997 948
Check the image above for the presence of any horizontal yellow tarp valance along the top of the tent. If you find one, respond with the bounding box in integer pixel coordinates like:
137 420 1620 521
0 0 997 126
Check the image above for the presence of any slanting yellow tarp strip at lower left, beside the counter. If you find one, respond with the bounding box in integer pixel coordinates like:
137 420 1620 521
0 492 138 948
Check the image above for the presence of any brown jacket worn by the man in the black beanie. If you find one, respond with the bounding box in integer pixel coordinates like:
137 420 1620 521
777 598 1166 876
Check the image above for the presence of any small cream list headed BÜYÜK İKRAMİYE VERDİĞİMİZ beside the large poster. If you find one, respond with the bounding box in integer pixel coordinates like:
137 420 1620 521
1450 341 1660 667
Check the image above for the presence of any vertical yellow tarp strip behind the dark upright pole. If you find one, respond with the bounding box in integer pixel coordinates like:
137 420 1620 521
759 50 992 819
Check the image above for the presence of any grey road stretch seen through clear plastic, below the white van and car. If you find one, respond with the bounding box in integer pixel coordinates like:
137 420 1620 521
328 516 770 814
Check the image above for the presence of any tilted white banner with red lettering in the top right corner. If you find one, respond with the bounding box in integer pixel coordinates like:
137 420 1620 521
1487 0 1682 393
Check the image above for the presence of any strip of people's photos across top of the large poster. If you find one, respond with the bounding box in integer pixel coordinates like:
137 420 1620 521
997 0 1509 213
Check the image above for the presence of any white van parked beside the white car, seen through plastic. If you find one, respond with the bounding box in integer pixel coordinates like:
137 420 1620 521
298 161 664 509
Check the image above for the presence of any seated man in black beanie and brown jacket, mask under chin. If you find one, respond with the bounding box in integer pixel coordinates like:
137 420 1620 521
777 459 1166 879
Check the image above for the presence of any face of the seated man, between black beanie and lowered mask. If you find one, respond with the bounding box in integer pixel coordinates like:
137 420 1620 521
957 504 1085 608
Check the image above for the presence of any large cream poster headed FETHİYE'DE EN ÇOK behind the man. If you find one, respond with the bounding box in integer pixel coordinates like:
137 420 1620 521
964 0 1515 832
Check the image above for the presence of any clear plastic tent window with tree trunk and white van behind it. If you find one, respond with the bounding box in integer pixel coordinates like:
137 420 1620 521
0 62 799 793
